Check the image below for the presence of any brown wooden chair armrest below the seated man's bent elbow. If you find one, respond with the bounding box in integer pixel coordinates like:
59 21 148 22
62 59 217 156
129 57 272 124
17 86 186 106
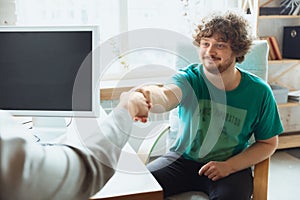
253 158 270 200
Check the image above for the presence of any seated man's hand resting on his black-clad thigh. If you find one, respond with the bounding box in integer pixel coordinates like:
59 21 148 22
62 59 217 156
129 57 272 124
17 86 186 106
198 161 230 181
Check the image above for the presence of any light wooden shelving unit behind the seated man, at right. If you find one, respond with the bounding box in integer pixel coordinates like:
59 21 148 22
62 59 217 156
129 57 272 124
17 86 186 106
254 0 300 149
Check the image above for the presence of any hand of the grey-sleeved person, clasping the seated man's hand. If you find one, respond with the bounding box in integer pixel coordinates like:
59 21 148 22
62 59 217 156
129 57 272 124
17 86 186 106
118 91 151 123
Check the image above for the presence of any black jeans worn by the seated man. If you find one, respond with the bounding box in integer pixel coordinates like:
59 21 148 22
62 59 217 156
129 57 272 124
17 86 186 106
147 152 253 200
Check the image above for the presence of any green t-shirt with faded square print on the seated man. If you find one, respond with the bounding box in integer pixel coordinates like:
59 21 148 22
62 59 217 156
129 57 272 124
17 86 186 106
171 64 283 163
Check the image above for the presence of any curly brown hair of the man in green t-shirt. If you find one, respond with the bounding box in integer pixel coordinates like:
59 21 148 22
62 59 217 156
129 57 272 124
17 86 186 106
193 11 252 63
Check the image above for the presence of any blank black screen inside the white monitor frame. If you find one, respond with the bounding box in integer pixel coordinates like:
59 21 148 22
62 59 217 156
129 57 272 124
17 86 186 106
0 31 92 111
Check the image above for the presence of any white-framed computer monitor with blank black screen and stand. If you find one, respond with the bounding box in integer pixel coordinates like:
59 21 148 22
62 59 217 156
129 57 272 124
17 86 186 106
0 26 100 140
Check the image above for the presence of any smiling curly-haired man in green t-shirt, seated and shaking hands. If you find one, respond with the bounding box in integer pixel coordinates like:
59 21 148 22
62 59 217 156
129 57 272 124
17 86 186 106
138 12 283 200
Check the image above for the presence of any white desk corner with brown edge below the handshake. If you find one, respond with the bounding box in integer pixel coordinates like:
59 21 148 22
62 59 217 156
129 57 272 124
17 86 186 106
90 144 163 200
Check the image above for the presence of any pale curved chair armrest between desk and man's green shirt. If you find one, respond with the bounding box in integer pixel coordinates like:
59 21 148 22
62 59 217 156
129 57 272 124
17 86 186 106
137 123 170 164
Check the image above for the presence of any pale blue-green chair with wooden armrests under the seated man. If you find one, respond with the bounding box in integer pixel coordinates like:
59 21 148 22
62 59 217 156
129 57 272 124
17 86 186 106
137 40 270 200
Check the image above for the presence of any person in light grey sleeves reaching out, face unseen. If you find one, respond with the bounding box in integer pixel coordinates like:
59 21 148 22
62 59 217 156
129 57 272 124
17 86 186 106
0 92 149 200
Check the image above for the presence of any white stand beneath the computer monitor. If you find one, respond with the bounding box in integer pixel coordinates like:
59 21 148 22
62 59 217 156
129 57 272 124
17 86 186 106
32 117 67 143
